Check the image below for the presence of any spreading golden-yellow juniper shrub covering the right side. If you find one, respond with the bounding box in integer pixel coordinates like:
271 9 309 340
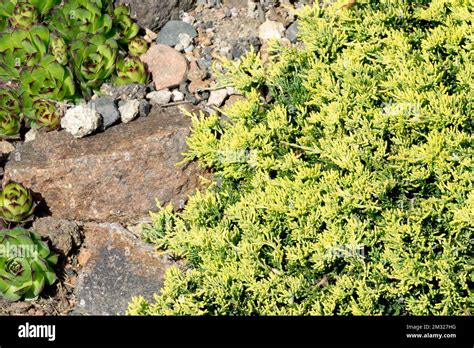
128 0 474 315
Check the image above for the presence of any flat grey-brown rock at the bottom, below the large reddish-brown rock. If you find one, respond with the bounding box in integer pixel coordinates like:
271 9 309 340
74 224 178 315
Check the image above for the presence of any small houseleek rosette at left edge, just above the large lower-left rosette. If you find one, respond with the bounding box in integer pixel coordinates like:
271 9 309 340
0 182 36 222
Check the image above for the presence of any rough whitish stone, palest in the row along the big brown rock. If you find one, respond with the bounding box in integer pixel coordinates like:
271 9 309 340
61 105 102 138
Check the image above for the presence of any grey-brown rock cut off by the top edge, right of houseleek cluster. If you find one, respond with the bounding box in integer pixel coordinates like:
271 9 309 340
115 0 196 30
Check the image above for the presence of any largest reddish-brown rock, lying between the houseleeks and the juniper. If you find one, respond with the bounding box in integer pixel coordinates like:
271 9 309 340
3 108 203 223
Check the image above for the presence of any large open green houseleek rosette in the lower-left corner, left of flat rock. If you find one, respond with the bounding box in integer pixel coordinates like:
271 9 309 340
0 228 58 302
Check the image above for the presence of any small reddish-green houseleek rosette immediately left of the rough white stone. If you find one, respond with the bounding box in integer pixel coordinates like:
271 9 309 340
27 100 61 131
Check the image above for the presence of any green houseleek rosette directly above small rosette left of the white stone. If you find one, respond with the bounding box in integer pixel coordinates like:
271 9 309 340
20 55 75 100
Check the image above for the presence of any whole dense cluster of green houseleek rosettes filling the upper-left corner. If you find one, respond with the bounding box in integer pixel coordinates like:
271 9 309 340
0 0 148 138
